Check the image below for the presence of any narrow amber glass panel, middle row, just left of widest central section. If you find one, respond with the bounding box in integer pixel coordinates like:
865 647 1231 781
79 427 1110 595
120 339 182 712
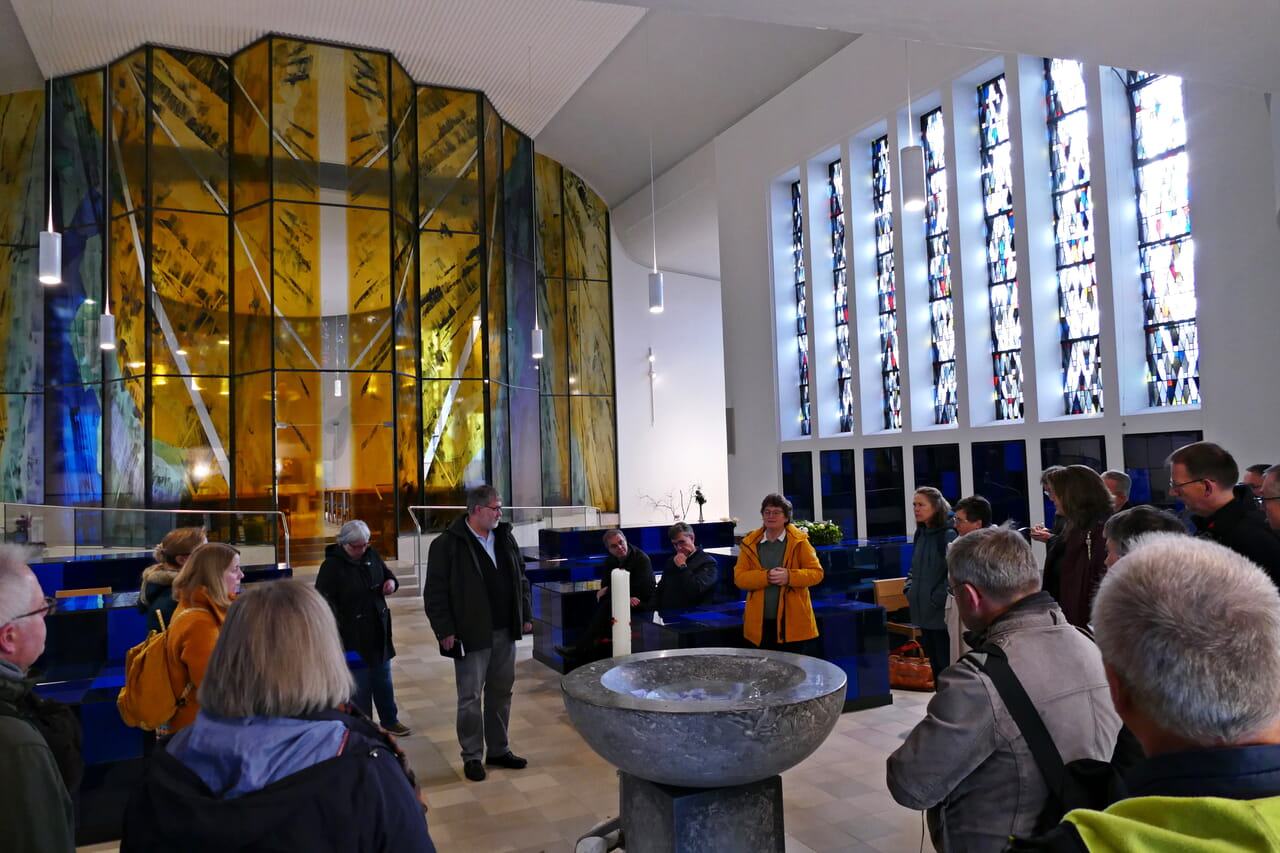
232 205 271 373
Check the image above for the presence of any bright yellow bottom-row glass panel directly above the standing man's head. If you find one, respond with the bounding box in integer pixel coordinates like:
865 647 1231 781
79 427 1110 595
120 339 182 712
422 379 485 494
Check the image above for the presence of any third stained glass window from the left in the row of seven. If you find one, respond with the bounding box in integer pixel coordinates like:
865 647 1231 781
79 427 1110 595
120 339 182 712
872 136 902 429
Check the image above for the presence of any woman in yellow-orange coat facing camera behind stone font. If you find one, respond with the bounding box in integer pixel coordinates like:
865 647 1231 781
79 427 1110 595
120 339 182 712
733 494 823 654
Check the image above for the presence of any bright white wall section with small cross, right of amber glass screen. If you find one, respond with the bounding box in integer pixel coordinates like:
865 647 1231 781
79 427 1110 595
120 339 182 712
613 229 731 524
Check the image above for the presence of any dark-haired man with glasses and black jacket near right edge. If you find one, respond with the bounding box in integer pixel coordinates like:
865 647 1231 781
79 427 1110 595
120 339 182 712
1166 442 1280 585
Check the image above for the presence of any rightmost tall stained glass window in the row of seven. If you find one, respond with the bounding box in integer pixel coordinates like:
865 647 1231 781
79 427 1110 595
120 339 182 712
1128 72 1201 406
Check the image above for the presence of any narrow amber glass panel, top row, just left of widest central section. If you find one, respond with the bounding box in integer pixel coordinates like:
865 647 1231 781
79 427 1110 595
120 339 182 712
230 40 271 210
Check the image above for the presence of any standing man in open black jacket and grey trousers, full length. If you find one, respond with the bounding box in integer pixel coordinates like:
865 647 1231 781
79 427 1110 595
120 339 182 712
422 485 534 781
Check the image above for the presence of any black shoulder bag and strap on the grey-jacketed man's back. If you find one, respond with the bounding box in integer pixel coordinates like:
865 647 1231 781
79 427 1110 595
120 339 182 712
970 644 1140 835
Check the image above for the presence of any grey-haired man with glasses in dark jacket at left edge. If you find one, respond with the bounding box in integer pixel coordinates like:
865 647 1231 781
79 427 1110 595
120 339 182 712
0 546 76 853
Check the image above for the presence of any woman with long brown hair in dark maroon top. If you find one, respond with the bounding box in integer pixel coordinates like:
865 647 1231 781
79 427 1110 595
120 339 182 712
1044 465 1114 628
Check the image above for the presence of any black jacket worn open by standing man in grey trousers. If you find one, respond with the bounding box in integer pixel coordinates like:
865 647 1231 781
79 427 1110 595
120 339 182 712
422 516 534 651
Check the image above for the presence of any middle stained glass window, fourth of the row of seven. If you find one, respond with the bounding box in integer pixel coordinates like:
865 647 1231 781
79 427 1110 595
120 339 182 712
920 108 959 424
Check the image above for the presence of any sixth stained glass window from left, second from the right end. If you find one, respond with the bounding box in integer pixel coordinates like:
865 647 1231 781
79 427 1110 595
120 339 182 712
1044 59 1102 415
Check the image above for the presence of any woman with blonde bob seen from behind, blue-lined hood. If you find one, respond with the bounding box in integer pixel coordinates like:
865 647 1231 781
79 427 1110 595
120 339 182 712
120 580 435 853
